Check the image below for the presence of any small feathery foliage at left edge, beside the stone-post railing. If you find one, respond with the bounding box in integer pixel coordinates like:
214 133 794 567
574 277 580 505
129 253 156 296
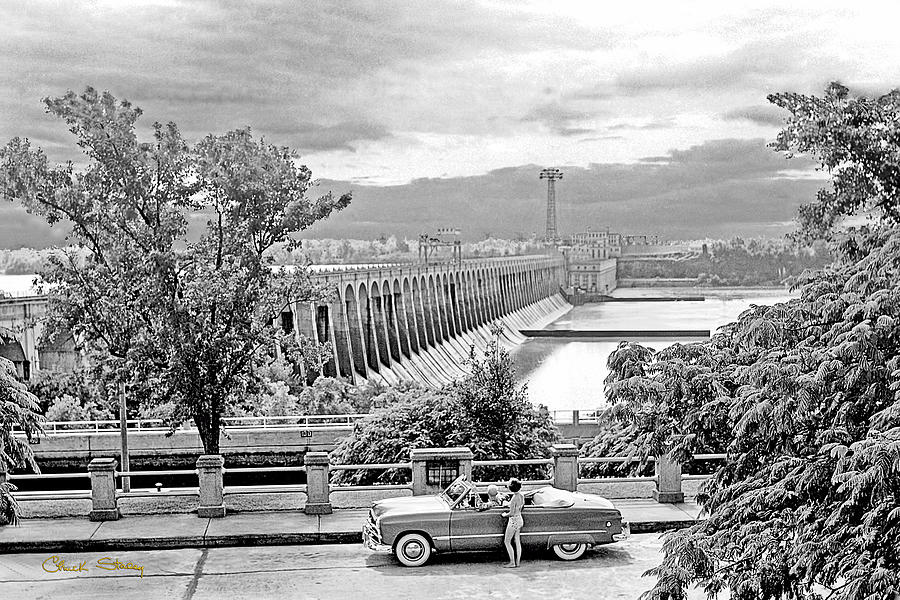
0 357 42 525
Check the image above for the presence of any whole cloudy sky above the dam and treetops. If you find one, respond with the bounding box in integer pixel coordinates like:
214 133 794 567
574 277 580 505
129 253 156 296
0 0 900 247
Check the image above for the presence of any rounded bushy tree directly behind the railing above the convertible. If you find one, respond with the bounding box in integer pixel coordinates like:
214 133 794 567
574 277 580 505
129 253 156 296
332 340 557 484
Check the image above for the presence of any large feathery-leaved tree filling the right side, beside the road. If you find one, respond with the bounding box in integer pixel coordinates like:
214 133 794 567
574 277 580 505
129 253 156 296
596 84 900 600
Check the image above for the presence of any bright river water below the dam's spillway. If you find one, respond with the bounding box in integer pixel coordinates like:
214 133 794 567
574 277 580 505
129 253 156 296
513 288 793 411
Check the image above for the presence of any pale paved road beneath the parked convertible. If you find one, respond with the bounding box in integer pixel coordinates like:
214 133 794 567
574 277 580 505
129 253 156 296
0 534 703 600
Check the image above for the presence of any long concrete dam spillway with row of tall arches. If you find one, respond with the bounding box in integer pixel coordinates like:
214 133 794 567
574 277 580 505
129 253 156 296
296 256 571 386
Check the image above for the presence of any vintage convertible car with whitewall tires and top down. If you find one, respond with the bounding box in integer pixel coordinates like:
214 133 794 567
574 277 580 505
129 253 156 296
363 475 630 567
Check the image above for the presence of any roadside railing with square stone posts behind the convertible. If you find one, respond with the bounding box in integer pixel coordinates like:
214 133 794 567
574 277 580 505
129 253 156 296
0 444 725 521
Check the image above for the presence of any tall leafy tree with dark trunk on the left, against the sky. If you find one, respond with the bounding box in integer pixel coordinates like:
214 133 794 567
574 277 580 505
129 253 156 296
0 88 350 453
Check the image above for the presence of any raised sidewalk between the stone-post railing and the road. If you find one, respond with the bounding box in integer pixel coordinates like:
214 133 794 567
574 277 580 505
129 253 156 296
0 500 700 554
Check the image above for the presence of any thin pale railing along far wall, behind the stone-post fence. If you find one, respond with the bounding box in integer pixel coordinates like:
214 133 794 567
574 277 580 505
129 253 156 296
13 410 599 435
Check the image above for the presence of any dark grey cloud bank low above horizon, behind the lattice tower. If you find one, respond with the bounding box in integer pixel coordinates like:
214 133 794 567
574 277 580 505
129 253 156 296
300 139 823 239
